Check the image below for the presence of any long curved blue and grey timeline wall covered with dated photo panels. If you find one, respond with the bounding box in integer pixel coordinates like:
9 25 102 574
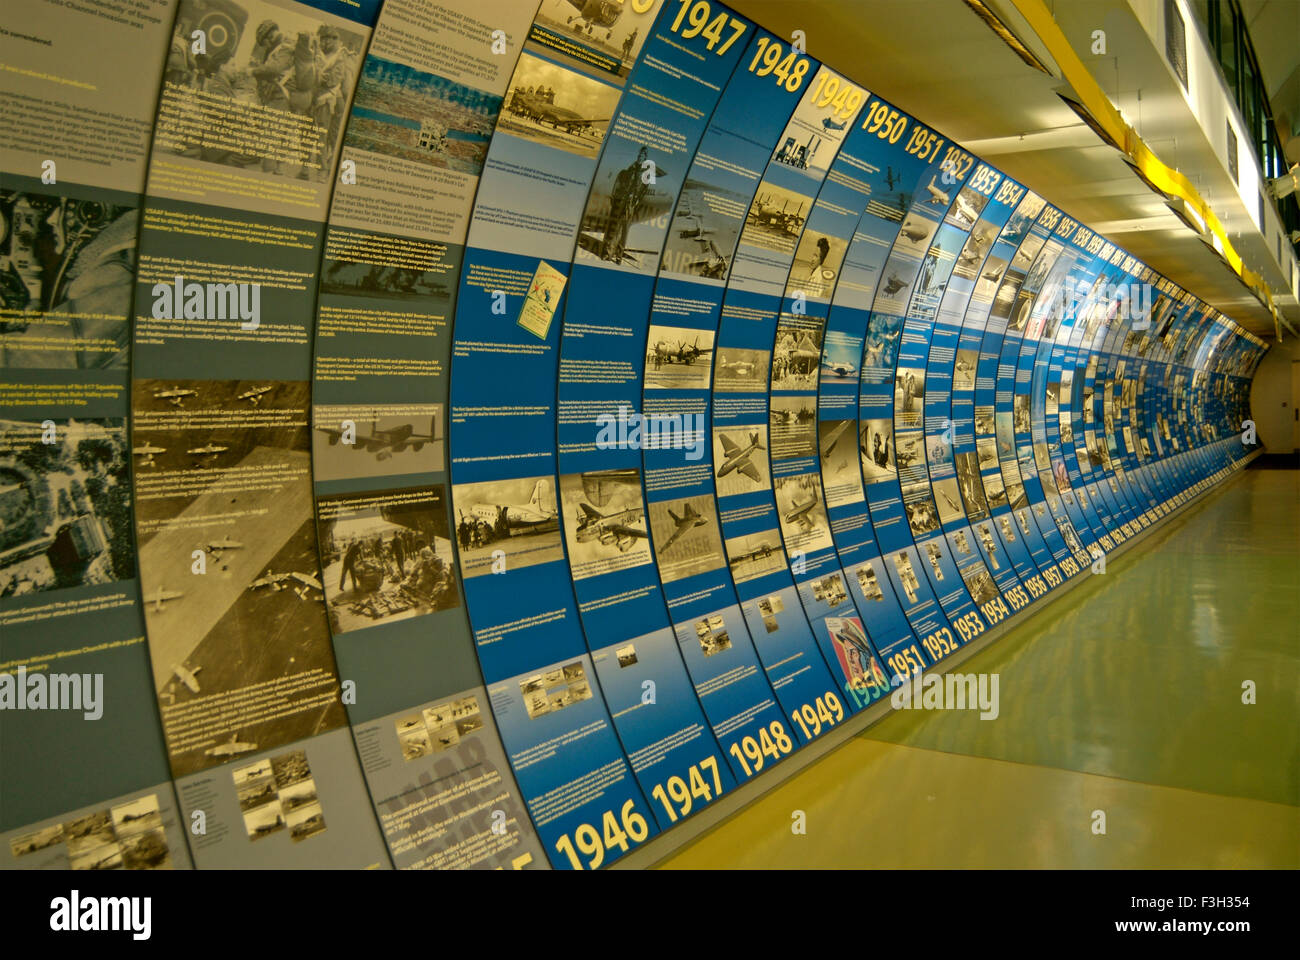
0 0 1266 869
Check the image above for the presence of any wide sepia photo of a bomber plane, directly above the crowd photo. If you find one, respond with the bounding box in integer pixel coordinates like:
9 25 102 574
312 403 447 483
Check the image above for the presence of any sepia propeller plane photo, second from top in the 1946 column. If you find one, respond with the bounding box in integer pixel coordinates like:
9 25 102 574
497 52 621 160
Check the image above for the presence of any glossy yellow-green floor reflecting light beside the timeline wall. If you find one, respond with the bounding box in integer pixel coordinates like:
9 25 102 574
664 470 1300 869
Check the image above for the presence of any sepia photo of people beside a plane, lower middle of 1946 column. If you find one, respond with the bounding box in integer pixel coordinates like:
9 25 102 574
452 476 564 578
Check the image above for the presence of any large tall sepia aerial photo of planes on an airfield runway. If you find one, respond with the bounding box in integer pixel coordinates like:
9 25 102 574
133 380 346 775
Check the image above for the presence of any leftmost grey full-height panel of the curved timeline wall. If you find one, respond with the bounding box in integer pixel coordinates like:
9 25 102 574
0 3 191 870
